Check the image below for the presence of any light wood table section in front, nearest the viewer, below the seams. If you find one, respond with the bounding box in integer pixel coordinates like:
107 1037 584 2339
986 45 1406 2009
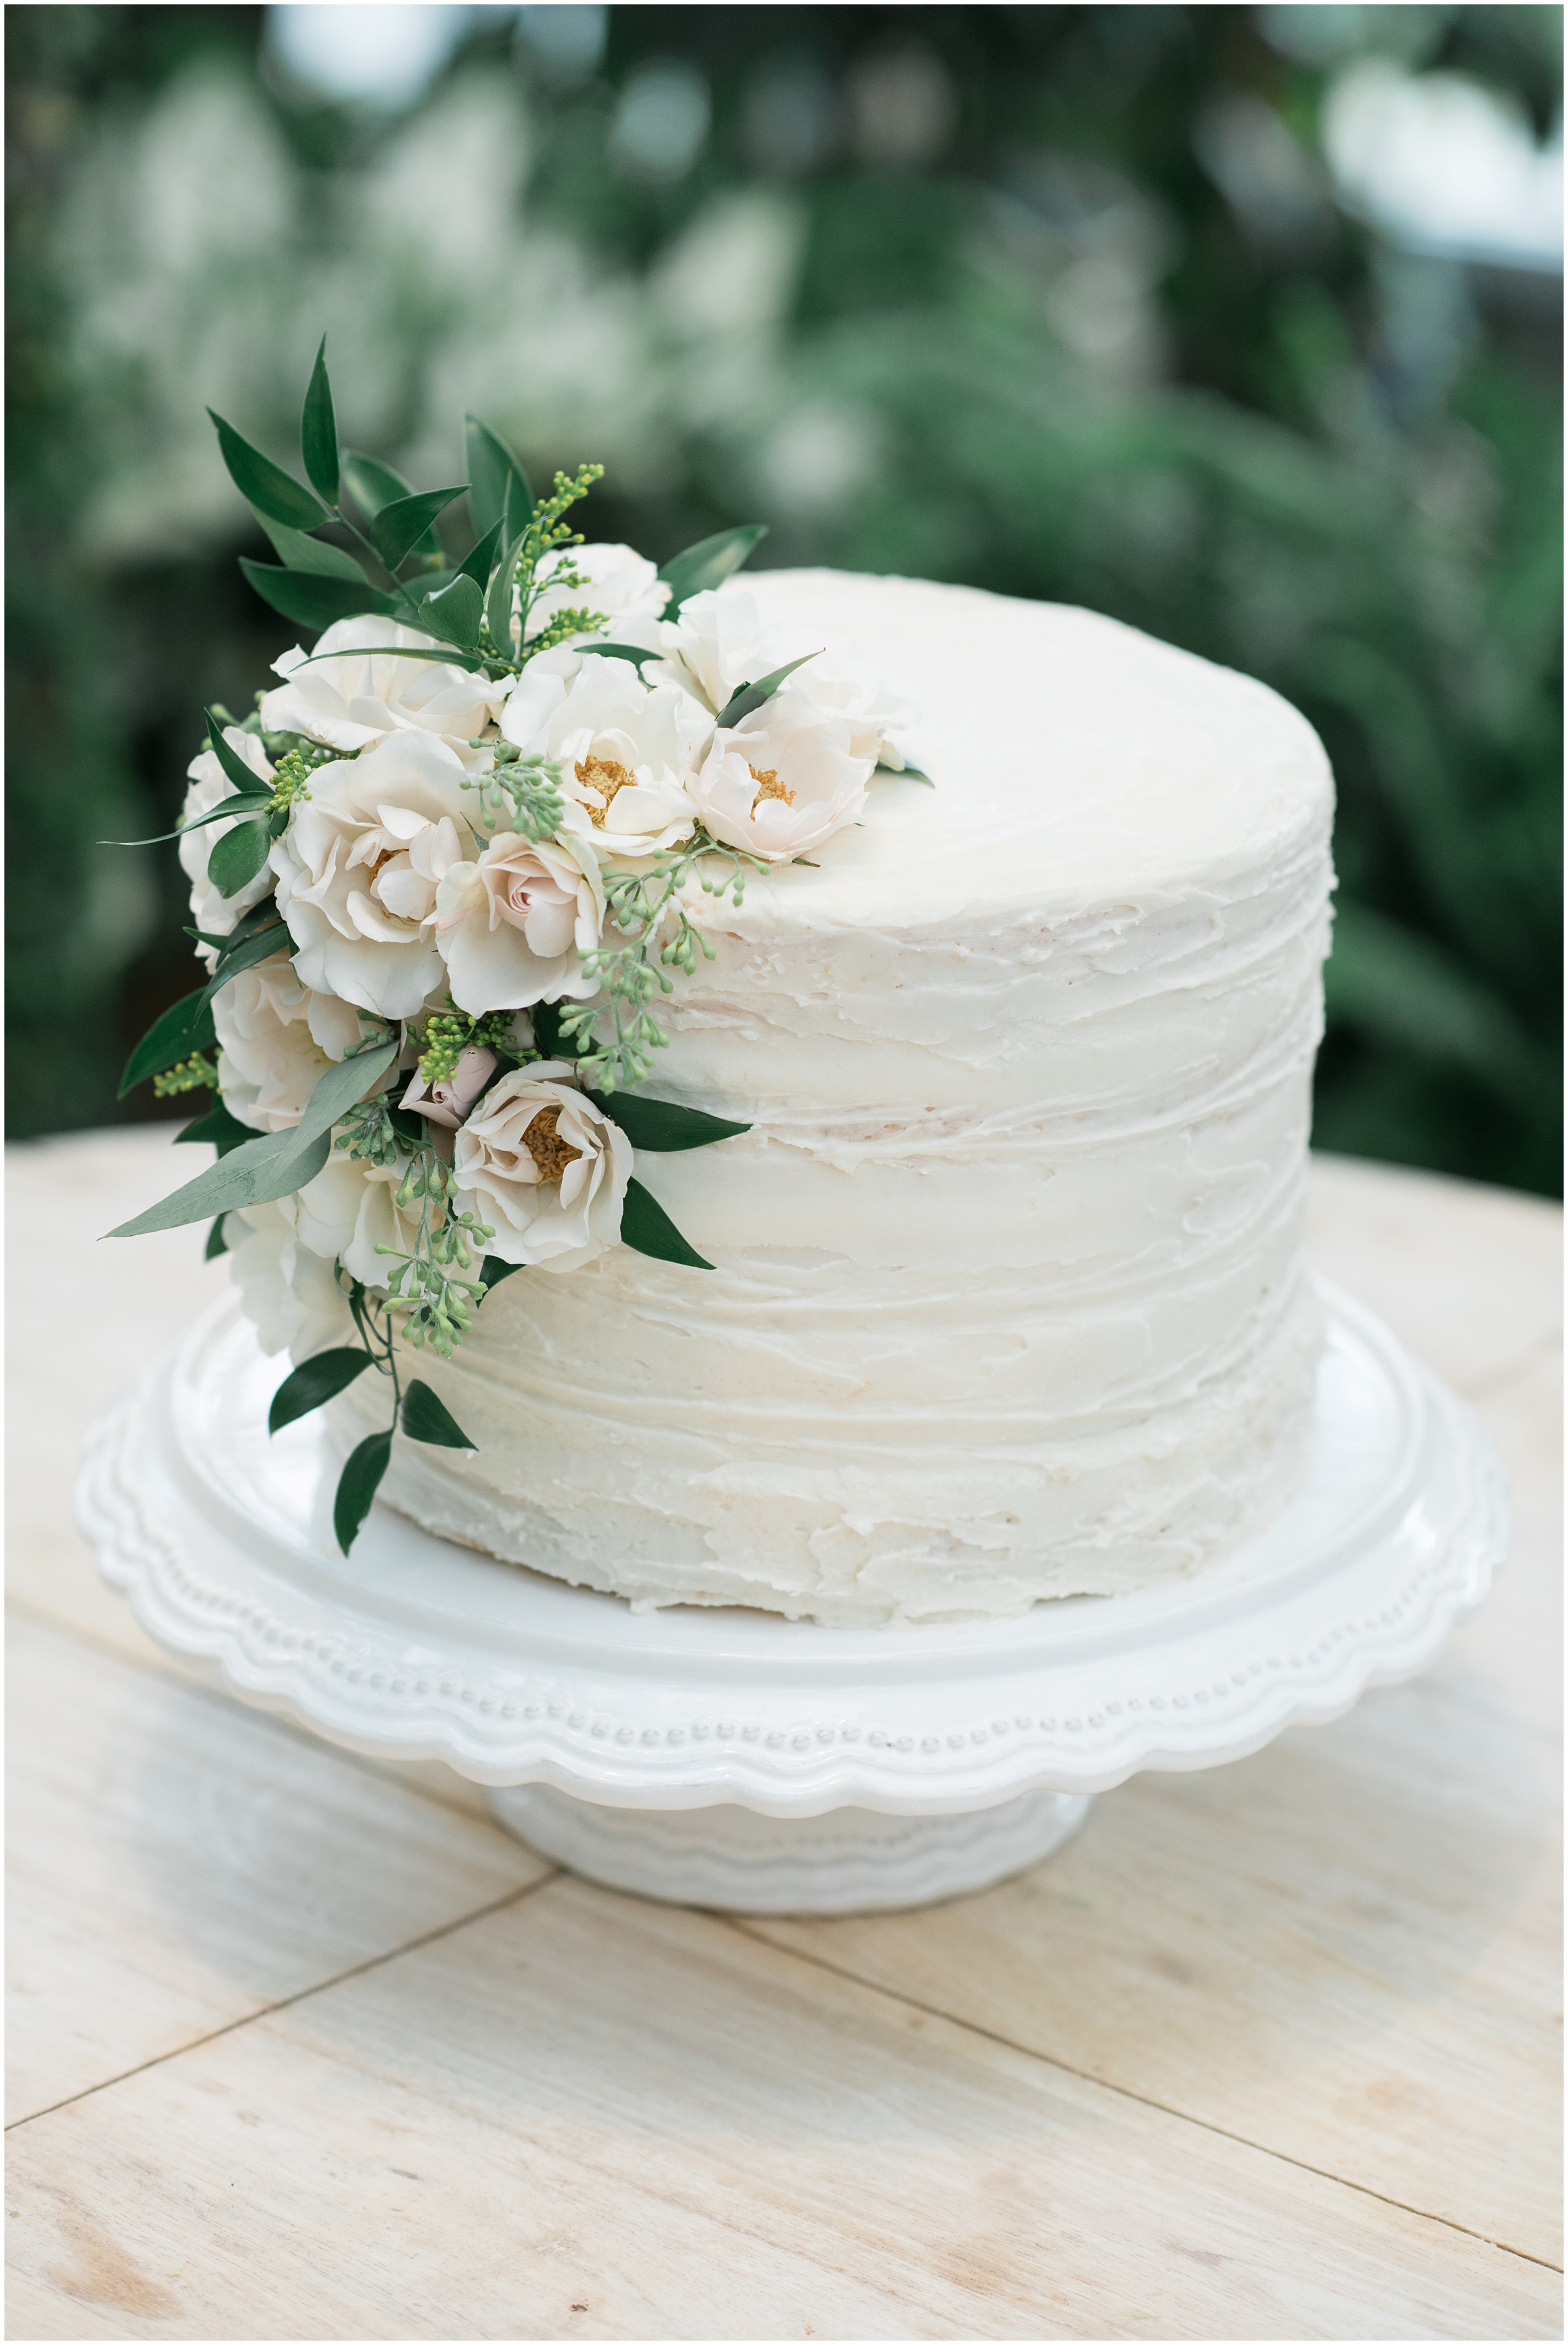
7 1881 1559 2338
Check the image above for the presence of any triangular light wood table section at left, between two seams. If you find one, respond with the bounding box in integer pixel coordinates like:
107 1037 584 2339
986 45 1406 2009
7 1623 544 2115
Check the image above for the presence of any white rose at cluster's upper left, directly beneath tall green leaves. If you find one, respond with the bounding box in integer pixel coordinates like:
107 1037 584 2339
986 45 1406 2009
260 617 506 767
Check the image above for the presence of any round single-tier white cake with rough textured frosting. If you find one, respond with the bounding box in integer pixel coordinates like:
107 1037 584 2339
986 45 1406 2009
331 570 1332 1627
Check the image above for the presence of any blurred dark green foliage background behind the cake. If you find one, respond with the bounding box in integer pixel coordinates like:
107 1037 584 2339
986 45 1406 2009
7 4 1561 1194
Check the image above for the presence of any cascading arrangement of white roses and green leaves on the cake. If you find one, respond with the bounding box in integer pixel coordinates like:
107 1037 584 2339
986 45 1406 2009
112 343 926 1553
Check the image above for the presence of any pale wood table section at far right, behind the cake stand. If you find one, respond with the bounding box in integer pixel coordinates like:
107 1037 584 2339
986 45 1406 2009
1308 1156 1564 1393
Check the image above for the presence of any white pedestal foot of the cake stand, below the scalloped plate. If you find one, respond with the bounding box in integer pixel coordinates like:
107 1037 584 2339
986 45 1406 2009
490 1782 1090 1913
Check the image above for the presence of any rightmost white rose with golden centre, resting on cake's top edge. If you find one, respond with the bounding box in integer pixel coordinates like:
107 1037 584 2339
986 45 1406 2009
691 684 874 863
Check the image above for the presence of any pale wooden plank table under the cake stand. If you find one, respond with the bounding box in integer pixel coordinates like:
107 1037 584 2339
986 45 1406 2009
7 1130 1561 2338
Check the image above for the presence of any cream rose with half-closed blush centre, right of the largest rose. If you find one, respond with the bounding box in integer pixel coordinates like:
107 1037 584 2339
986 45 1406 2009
433 830 605 1018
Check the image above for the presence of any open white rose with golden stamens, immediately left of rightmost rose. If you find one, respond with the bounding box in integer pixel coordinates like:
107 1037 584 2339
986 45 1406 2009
502 654 712 856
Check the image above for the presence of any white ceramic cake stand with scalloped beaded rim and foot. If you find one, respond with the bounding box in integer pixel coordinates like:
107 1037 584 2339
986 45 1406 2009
77 1290 1507 1913
